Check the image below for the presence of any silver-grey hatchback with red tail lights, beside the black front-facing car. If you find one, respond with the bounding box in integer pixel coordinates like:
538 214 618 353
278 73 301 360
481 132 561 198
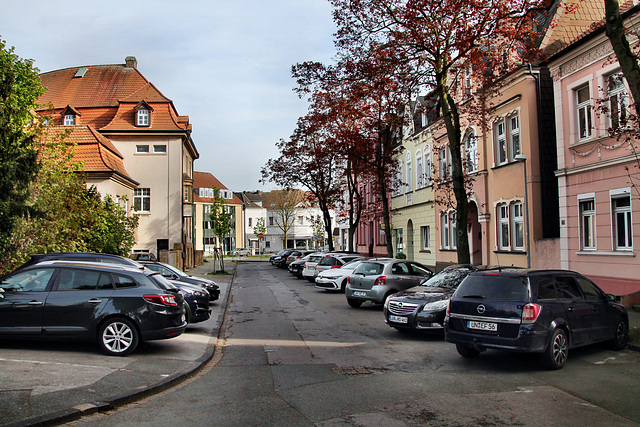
345 259 433 307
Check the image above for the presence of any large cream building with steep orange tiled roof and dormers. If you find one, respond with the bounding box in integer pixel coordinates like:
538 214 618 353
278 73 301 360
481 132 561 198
38 57 199 268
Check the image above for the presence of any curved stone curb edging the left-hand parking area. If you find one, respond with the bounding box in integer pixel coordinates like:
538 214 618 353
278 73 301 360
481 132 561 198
10 265 237 427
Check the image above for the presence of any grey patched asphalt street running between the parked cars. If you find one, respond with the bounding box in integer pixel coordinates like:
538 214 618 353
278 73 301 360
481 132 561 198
63 262 640 426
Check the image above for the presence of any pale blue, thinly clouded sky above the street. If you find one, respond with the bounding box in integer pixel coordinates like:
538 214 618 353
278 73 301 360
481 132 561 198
0 0 335 191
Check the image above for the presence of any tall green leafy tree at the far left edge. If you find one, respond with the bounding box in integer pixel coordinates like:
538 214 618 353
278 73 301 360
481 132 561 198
0 39 44 251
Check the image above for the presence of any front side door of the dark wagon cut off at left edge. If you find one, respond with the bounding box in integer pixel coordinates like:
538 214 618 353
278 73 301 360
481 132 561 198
0 267 55 336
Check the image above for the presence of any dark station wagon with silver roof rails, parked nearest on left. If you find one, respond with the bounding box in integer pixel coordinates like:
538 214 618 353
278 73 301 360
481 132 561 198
0 261 187 356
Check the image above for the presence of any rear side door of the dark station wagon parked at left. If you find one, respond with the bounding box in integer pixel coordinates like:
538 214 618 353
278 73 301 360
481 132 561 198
42 268 114 336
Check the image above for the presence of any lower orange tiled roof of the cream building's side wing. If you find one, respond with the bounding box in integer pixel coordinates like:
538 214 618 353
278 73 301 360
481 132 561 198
40 126 138 188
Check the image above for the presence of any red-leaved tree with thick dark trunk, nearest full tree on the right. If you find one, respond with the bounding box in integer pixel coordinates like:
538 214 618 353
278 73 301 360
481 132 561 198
331 0 551 263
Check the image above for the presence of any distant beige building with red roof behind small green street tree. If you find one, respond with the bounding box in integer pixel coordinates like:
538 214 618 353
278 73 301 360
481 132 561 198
193 172 244 255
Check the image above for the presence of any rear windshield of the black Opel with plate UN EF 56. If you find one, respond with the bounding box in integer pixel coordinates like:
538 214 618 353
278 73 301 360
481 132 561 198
455 275 529 301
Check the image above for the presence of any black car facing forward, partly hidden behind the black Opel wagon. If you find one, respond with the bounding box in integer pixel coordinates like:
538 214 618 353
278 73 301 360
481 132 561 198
383 264 498 332
